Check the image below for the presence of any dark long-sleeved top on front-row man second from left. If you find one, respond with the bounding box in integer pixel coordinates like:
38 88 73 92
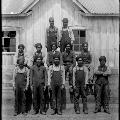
30 65 47 86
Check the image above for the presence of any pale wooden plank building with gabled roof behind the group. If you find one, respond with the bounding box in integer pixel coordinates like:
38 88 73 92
2 0 119 103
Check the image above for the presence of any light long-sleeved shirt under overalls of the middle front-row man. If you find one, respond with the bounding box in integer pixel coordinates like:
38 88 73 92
48 64 65 85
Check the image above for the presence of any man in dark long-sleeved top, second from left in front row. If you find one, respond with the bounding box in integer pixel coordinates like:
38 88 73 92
30 55 47 115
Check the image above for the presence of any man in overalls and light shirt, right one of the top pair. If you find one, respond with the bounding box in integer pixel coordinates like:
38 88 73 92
59 18 75 52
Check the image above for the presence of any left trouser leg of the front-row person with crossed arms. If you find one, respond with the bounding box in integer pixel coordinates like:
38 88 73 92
95 84 102 110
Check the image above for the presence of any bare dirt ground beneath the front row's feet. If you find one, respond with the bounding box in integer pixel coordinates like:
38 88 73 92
2 87 119 120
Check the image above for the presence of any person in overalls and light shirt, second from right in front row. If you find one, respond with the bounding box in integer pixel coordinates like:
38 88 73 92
73 55 88 114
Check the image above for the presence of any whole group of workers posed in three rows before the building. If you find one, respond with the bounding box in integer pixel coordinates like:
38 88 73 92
13 17 111 116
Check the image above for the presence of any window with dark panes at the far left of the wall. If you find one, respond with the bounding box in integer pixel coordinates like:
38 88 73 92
2 31 16 52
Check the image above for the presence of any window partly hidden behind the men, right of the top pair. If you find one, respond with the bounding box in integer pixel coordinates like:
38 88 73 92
73 29 86 52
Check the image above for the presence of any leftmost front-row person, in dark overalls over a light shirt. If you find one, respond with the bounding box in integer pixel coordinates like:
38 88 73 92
13 56 29 116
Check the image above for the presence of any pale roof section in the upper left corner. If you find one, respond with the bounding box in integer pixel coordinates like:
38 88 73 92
2 0 35 14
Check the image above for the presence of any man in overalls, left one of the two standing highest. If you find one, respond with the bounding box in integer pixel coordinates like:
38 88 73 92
45 17 59 52
